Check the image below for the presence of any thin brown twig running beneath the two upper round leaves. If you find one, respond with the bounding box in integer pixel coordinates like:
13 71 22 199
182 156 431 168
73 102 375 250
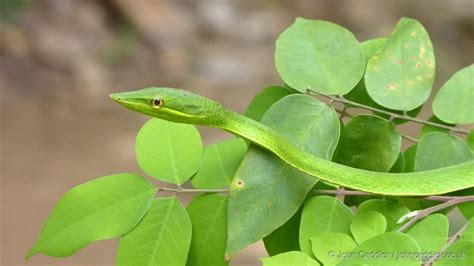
306 88 469 134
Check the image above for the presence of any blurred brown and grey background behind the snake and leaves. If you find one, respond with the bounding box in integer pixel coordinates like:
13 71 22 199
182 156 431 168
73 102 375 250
0 0 474 265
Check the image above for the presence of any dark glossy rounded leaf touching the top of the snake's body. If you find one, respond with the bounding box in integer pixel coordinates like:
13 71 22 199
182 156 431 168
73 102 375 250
338 115 401 172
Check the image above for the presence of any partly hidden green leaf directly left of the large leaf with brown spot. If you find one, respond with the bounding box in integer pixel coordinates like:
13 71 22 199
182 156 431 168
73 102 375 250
187 194 228 266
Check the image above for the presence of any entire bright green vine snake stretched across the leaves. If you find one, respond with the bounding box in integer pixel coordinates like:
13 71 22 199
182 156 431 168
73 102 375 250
110 87 474 196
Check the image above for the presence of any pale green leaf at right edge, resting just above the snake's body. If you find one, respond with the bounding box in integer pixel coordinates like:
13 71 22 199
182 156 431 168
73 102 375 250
415 132 472 172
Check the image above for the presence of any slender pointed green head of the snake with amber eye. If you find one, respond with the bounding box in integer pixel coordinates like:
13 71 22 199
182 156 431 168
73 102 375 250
110 87 224 126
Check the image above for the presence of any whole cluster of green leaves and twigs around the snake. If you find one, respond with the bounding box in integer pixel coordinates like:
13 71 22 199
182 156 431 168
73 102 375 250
27 18 474 265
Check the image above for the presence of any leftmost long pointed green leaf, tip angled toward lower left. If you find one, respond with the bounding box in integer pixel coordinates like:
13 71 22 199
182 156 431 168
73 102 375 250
26 173 156 258
